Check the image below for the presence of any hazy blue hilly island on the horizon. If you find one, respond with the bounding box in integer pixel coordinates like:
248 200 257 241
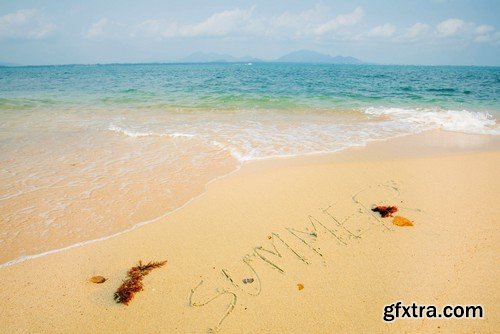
179 50 363 65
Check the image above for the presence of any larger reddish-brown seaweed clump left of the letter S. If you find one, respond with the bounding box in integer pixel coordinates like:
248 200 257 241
114 260 167 305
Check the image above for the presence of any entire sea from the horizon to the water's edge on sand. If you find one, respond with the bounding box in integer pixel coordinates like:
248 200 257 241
0 63 500 266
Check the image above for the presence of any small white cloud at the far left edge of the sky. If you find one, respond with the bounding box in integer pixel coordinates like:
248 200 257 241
0 9 55 39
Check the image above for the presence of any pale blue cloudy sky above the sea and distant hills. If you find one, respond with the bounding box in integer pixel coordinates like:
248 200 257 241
0 0 500 66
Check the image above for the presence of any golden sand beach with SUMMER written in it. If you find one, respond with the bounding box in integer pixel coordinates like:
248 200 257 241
0 132 500 333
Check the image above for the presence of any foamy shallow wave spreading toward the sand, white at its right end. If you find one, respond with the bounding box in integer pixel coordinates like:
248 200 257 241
108 107 500 163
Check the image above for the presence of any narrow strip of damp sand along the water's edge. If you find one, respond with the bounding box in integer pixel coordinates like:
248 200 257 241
0 130 500 269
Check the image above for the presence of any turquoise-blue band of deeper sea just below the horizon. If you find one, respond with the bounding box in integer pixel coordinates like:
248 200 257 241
0 64 500 111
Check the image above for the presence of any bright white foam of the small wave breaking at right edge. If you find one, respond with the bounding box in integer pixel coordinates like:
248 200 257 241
364 107 500 135
